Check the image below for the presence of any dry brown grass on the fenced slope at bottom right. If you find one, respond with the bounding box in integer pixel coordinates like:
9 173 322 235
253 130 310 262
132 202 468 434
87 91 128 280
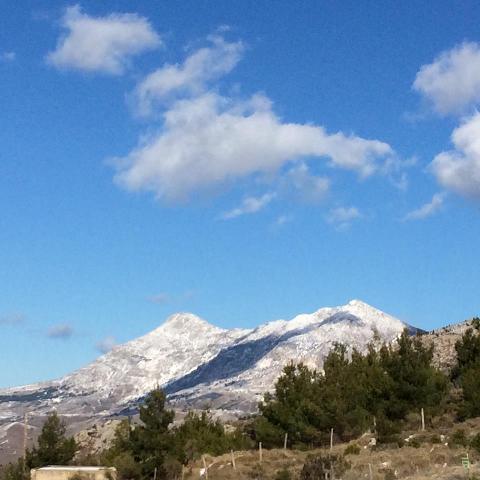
184 419 480 480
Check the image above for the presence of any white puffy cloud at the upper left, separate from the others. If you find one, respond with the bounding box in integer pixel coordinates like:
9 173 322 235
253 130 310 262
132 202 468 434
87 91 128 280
47 5 162 75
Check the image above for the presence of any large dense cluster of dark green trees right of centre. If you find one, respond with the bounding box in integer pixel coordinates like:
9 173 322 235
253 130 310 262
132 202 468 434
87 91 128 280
254 332 448 448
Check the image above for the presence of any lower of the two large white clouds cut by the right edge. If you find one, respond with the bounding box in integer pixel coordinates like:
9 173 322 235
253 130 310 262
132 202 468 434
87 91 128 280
430 113 480 199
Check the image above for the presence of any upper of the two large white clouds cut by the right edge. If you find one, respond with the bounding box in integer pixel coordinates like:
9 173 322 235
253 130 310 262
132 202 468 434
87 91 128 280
413 42 480 115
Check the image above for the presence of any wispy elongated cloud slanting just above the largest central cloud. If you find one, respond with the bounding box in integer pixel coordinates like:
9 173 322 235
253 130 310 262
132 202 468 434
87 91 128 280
134 36 244 115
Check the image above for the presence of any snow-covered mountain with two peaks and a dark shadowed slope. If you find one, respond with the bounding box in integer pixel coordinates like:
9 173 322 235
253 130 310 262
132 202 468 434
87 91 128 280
0 300 411 462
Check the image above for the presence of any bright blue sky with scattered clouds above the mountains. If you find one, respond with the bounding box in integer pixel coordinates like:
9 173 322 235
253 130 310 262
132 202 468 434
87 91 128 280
0 0 480 386
